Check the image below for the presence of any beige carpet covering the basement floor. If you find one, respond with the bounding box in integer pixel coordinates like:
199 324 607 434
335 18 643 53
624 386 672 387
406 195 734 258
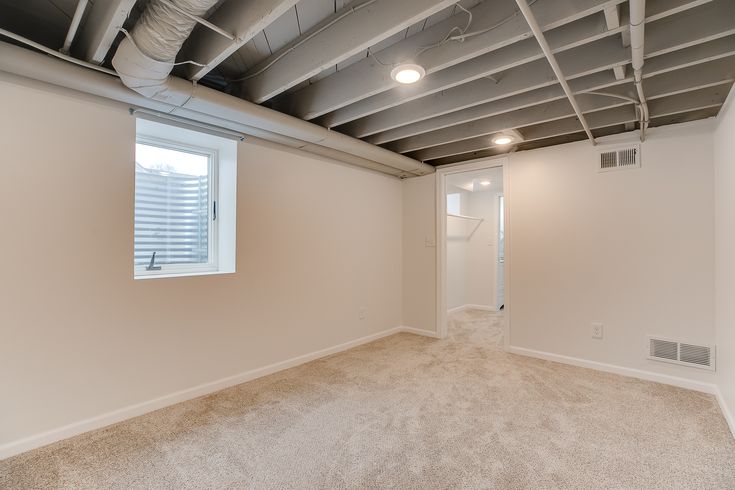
0 312 735 489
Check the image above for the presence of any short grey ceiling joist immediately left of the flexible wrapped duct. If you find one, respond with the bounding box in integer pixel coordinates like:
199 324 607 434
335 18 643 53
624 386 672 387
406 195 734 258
73 0 135 65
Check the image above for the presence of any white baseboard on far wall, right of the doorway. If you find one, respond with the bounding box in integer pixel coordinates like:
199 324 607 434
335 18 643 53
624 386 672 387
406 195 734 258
508 345 718 395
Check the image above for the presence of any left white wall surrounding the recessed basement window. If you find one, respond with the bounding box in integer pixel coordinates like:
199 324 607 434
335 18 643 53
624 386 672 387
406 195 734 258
0 81 402 452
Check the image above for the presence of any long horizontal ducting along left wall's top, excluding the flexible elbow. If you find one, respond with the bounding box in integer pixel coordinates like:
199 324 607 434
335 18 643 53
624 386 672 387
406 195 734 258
0 42 435 177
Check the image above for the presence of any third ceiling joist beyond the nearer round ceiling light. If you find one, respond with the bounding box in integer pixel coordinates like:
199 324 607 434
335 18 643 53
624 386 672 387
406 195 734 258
365 36 735 144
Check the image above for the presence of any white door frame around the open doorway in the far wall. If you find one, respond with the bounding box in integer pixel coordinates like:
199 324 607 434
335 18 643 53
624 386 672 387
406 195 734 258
435 156 512 351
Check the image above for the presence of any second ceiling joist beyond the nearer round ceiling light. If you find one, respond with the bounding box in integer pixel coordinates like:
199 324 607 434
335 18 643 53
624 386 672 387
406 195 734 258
340 2 735 138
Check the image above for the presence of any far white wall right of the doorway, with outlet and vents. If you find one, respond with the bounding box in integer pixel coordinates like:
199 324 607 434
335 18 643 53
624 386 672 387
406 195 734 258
404 122 722 383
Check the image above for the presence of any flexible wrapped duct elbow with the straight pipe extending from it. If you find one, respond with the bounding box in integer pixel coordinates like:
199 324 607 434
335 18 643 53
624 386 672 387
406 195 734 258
106 0 434 175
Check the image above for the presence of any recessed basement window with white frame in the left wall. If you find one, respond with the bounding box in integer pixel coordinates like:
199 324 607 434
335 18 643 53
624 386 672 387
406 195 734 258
133 119 237 279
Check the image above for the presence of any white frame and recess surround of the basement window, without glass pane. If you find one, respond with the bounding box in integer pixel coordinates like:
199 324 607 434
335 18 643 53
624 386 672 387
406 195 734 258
133 118 237 279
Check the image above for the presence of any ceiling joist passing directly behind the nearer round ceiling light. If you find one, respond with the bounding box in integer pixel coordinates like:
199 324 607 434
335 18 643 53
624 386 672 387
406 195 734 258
320 0 699 128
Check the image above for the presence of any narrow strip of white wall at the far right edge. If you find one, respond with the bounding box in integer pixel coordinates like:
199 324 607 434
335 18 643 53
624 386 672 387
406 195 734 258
714 91 735 433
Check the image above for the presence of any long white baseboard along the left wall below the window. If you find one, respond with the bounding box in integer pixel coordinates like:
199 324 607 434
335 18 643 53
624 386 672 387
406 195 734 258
0 326 408 460
